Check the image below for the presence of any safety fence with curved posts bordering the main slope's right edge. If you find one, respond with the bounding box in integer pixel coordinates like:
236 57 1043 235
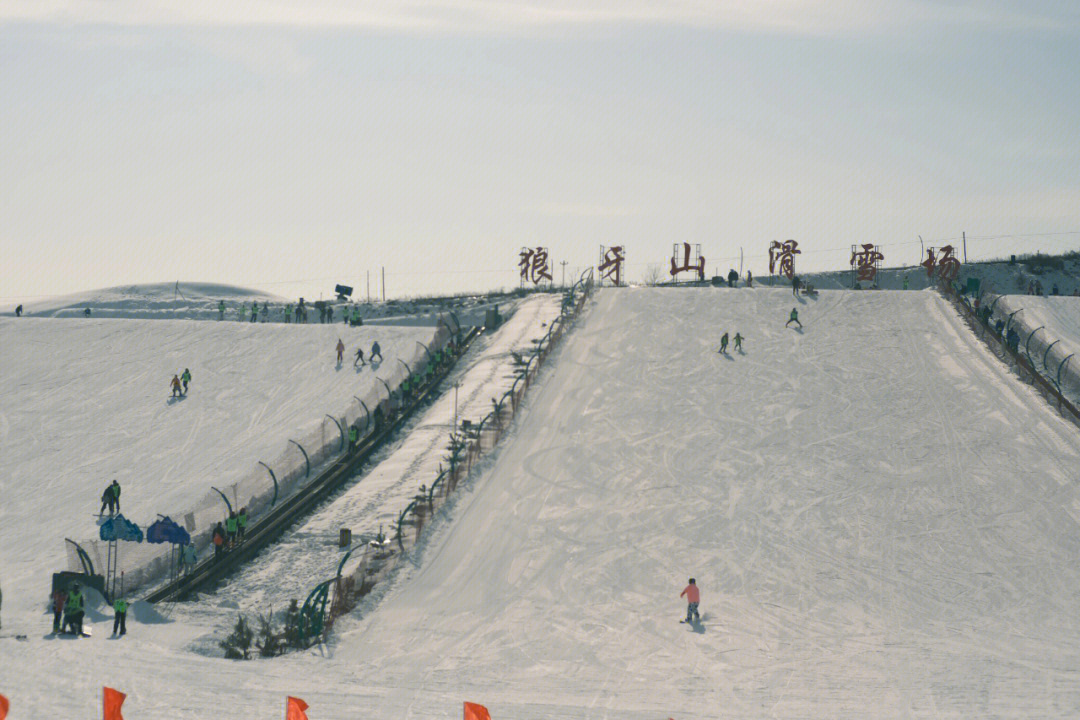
939 283 1080 424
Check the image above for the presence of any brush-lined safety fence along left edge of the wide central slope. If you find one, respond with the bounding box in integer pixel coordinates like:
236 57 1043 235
315 268 594 643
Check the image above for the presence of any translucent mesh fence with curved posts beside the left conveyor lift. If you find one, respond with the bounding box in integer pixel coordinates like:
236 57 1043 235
66 321 460 593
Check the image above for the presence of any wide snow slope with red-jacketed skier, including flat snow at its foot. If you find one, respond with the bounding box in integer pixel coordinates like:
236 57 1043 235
0 288 1080 720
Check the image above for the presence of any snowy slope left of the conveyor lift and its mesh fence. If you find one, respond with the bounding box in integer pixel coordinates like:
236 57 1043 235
0 317 433 617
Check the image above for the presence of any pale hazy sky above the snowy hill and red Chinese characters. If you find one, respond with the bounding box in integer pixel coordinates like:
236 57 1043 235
0 0 1080 305
